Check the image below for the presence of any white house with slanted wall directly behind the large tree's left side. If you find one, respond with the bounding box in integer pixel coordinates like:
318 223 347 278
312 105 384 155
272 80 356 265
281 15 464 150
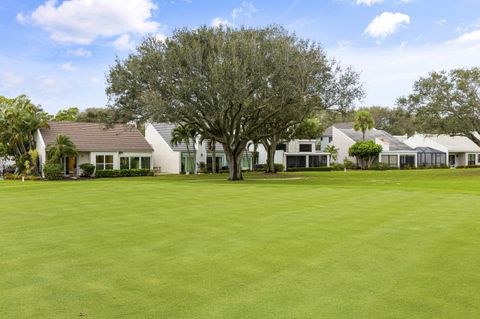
145 123 251 174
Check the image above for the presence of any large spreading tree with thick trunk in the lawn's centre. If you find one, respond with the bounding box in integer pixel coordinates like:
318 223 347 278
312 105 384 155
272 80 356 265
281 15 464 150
107 27 363 180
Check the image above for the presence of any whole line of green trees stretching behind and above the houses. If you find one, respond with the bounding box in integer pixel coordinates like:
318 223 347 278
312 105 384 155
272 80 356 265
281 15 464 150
0 26 480 180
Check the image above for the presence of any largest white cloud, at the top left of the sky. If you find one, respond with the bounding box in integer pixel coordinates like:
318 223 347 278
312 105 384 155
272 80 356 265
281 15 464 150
17 0 160 44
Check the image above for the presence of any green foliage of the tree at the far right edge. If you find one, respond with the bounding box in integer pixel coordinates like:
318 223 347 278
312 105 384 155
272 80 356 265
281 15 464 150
397 67 480 142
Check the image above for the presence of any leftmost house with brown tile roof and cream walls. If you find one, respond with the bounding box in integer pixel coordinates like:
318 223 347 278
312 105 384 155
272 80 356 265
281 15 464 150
35 121 153 176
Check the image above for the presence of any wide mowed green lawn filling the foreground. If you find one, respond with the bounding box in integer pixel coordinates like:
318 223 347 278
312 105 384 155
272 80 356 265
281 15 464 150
0 169 480 318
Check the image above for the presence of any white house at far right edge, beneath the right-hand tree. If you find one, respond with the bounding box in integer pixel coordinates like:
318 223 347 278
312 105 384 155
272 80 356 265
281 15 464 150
404 134 480 167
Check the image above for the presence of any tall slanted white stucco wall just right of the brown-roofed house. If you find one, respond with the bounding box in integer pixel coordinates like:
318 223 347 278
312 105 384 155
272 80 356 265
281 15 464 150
145 124 181 174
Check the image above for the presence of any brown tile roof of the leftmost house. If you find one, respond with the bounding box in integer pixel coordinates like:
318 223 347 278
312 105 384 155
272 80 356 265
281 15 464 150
40 122 152 152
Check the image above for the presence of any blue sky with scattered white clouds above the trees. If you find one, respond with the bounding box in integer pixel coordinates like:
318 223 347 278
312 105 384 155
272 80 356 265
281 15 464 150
0 0 480 112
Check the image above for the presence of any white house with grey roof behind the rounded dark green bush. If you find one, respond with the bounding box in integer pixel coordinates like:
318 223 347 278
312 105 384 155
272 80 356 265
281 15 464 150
327 125 417 168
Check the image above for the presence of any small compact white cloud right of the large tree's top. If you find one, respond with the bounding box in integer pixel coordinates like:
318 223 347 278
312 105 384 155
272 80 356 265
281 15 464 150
365 12 410 39
